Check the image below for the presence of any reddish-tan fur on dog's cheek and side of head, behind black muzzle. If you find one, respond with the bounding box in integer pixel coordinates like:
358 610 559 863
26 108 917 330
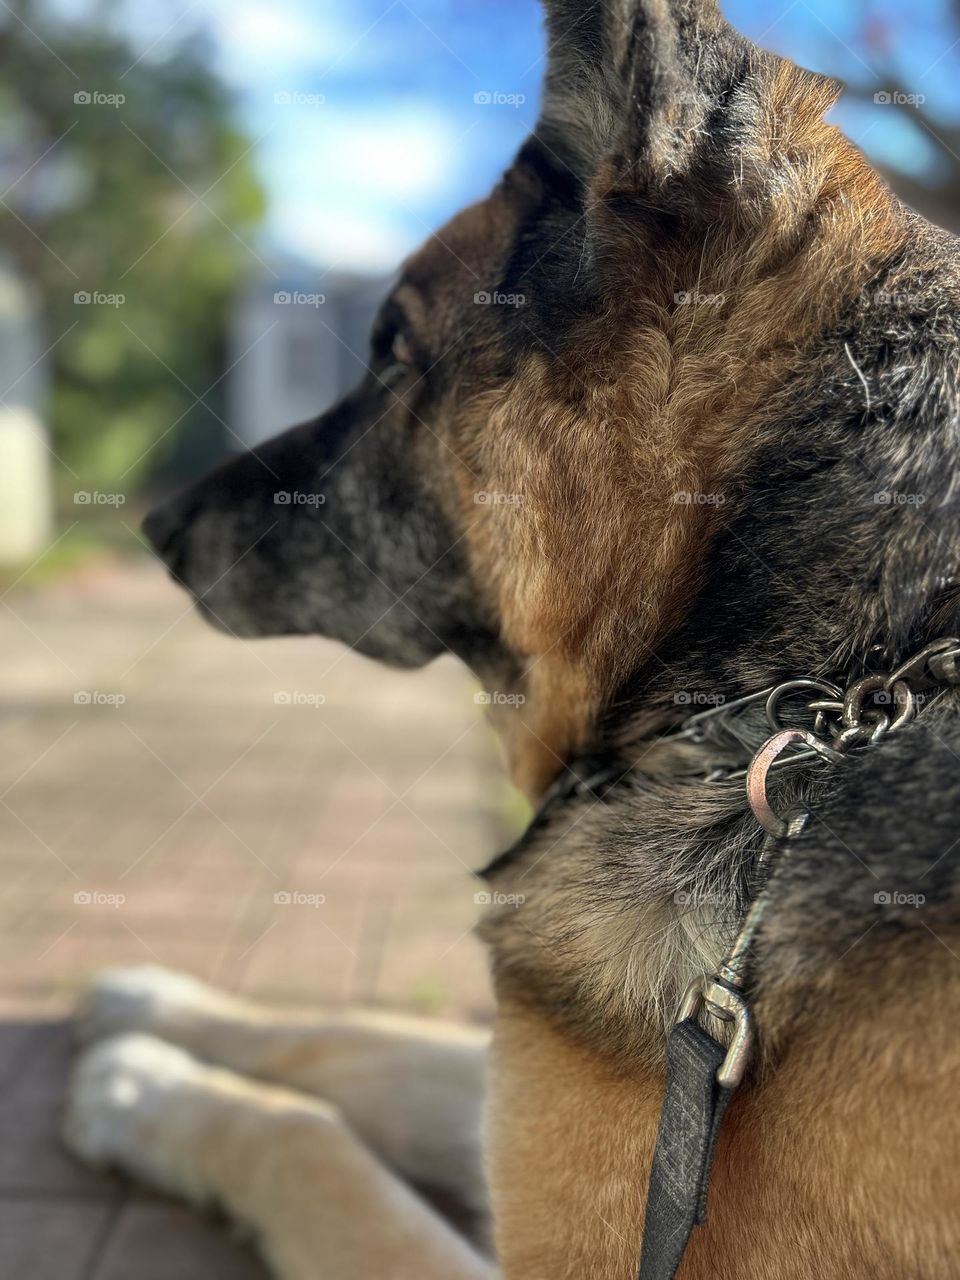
452 64 902 794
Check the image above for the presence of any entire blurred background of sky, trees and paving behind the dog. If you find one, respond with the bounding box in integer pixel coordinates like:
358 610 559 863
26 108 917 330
0 0 960 1280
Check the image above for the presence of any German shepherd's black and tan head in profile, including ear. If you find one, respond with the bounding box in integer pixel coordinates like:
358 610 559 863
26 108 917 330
146 0 896 792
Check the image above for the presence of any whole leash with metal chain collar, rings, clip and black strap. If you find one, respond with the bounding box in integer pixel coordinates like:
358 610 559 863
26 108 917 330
639 637 960 1280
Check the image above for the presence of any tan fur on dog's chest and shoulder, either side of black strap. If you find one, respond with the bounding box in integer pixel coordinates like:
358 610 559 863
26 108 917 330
489 954 960 1280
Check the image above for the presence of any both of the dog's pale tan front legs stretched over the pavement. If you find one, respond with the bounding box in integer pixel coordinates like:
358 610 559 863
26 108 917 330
65 968 494 1280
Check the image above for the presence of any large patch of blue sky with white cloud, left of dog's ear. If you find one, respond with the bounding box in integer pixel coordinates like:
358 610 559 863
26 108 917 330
211 0 544 269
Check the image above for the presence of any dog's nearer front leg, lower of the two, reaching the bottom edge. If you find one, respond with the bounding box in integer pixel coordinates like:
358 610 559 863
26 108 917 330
65 1036 494 1280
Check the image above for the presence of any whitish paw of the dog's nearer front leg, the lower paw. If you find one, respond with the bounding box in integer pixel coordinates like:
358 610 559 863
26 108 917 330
63 1034 205 1193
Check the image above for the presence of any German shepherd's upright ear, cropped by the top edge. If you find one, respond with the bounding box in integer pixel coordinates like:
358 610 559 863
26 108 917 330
536 0 840 212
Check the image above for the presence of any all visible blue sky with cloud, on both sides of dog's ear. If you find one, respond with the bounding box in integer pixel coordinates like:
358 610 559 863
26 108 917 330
60 0 960 271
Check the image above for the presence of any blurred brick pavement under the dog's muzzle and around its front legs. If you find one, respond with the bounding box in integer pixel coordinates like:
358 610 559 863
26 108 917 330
0 563 520 1280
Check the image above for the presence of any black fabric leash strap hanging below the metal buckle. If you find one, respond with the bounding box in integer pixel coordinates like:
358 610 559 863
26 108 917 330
640 1018 733 1280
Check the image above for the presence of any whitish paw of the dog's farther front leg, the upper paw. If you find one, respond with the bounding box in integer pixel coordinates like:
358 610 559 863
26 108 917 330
77 965 216 1042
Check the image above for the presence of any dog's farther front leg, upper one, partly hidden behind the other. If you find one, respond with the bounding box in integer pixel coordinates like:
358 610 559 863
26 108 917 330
78 966 488 1219
